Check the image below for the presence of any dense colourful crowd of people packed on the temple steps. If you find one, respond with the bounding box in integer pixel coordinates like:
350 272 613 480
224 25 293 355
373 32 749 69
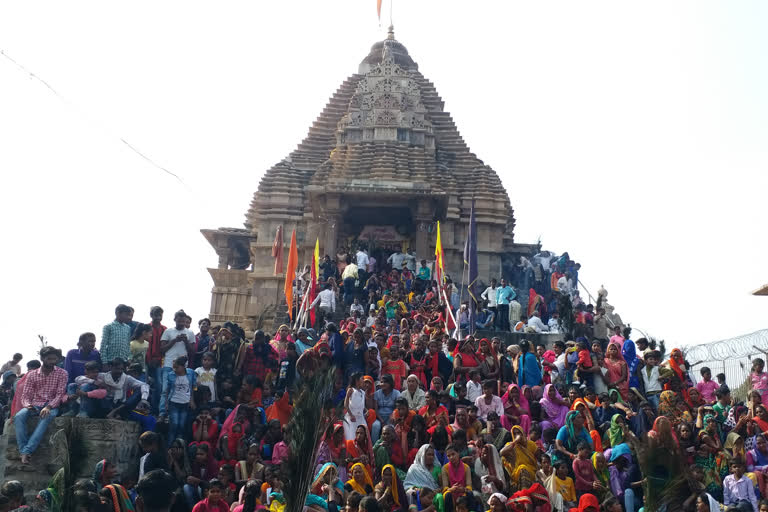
0 248 768 512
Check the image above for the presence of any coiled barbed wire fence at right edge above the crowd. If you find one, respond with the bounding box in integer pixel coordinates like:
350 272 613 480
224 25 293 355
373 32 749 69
683 329 768 399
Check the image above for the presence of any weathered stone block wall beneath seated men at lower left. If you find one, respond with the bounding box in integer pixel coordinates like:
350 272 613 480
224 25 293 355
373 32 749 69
0 418 140 498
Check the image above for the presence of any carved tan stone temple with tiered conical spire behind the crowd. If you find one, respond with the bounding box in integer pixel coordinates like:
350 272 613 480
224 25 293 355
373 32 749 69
202 27 538 330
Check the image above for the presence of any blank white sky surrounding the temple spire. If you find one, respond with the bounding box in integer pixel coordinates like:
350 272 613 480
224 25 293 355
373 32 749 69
0 0 768 360
